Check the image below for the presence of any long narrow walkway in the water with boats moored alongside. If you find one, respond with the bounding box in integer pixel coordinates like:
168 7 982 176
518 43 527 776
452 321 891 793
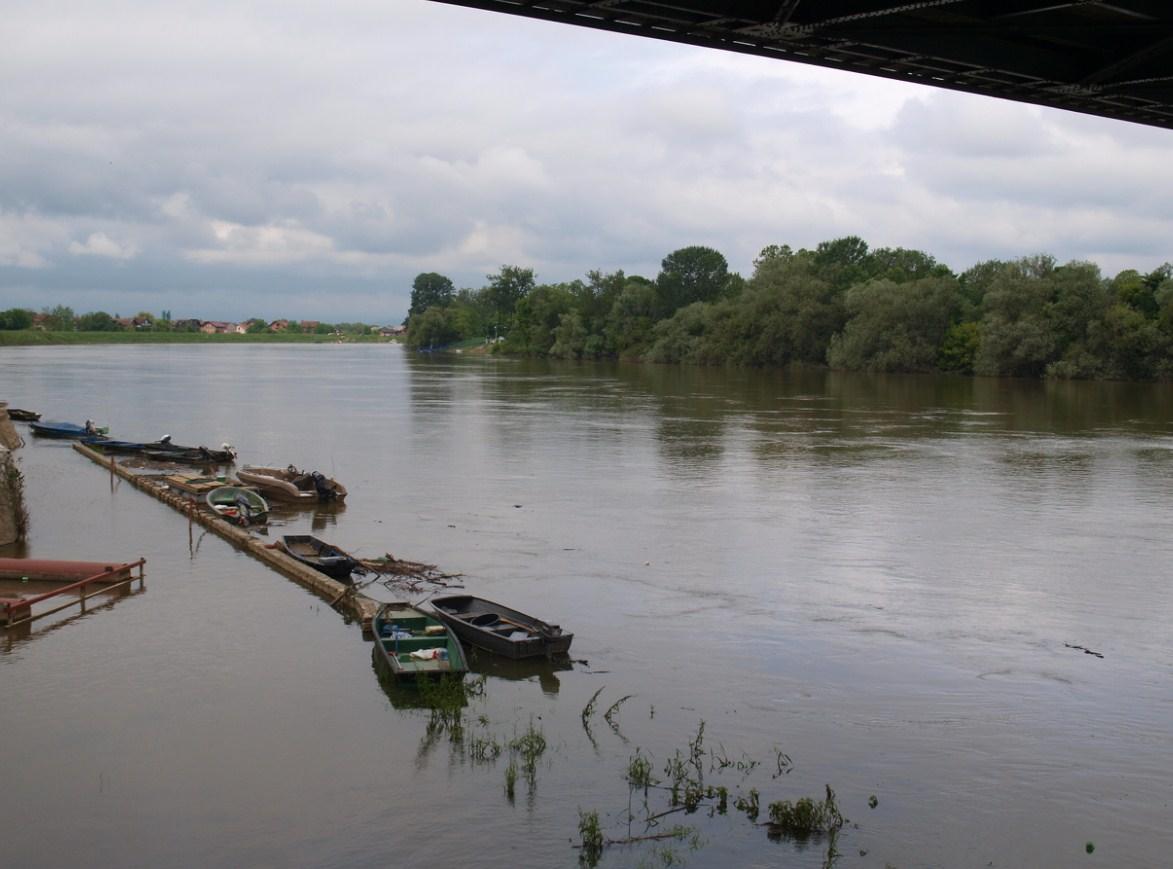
74 443 379 633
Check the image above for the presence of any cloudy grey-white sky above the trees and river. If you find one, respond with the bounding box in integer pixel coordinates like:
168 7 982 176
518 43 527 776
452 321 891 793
0 0 1173 324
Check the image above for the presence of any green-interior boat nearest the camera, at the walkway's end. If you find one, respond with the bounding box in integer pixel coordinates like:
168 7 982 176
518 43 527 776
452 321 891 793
371 603 468 679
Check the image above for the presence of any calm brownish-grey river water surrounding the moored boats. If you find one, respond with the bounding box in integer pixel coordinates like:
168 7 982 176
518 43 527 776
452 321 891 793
0 345 1173 869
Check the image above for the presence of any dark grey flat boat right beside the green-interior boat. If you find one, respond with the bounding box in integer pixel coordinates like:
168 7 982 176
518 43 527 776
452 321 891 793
432 595 575 659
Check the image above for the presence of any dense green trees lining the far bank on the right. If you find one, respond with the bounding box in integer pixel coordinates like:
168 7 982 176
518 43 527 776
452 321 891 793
406 242 1173 380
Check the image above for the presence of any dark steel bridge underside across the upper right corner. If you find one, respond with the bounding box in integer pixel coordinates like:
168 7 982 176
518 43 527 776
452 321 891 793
426 0 1173 129
